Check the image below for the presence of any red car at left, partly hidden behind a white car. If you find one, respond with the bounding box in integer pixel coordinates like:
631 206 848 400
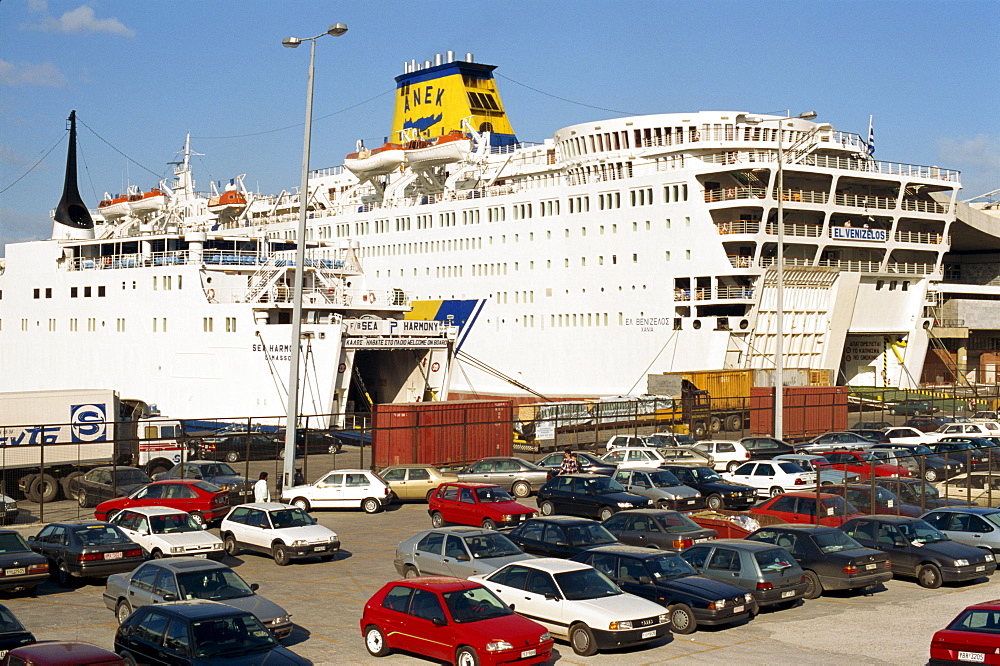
94 479 229 527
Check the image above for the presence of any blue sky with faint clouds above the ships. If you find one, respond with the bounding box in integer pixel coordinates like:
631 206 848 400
0 0 1000 252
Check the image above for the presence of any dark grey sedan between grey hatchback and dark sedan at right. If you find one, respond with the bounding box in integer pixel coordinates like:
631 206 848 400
747 525 892 599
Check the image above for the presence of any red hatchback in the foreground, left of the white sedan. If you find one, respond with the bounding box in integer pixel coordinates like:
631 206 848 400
361 576 552 666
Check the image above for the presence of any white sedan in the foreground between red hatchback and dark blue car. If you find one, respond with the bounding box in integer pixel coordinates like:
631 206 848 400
471 558 670 656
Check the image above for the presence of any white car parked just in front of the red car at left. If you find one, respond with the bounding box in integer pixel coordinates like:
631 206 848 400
109 506 226 561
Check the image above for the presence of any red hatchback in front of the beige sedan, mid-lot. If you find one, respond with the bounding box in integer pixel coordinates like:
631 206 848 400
427 483 536 530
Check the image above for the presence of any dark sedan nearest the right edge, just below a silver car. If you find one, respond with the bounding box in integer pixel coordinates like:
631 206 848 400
837 515 997 589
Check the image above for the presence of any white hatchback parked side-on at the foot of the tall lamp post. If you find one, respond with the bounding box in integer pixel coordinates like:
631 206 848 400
281 469 390 513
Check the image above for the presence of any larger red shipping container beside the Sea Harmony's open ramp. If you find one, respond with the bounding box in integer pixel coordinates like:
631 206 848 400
372 400 514 468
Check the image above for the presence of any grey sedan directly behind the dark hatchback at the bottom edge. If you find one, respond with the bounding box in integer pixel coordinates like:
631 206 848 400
104 557 292 640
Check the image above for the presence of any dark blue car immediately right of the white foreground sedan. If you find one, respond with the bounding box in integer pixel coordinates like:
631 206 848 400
570 546 757 634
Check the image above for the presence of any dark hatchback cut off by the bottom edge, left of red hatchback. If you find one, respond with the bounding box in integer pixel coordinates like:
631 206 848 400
115 599 312 666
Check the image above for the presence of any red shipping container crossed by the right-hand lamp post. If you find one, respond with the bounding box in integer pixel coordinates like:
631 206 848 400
750 386 850 441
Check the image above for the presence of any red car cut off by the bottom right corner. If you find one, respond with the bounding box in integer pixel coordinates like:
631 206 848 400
930 599 1000 664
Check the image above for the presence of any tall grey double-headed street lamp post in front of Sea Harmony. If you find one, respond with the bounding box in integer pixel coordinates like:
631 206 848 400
281 23 347 488
